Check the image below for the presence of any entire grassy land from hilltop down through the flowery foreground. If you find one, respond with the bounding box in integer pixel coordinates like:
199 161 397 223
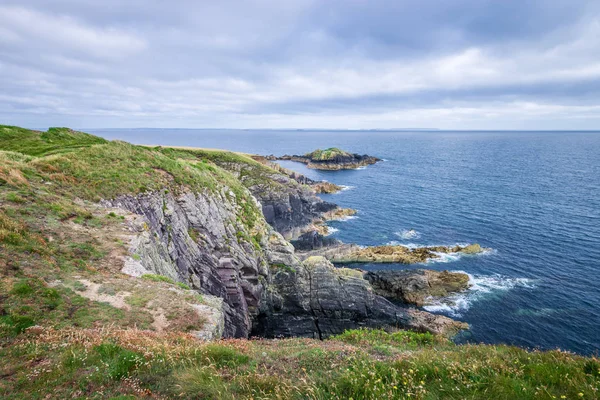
0 127 600 399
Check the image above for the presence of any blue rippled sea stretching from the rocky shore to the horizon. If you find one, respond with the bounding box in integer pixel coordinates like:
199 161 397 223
87 129 600 354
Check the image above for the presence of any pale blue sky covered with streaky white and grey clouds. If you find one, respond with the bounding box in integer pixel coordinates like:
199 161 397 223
0 0 600 130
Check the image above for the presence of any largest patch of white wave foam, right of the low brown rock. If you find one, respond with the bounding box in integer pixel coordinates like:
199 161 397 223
423 271 535 317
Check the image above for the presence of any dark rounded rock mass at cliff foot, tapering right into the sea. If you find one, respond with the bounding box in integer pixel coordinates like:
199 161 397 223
252 257 465 339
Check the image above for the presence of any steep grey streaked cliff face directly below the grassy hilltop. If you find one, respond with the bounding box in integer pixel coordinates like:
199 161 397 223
104 190 268 337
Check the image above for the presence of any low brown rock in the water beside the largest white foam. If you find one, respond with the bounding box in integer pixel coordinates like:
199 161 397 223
364 269 469 306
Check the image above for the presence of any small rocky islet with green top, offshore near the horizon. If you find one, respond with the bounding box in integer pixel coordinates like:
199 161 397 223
274 147 381 170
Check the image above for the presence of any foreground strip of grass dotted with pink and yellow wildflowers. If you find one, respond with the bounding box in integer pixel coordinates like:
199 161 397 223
0 328 600 399
